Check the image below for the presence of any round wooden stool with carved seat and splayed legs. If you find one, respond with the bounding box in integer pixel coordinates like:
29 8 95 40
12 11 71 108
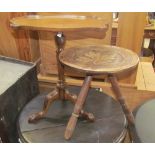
59 46 139 139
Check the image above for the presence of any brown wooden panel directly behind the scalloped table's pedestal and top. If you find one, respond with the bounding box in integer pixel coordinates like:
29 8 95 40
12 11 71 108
28 12 112 76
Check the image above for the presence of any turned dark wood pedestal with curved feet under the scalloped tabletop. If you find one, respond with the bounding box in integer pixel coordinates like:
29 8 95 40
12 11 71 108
28 32 94 123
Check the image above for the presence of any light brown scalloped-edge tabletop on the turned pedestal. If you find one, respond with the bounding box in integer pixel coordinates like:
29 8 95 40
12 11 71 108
10 15 108 32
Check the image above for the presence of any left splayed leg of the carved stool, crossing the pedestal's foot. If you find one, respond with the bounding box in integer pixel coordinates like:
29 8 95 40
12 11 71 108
64 76 92 139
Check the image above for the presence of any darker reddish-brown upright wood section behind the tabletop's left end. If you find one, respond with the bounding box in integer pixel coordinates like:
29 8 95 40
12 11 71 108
10 12 40 62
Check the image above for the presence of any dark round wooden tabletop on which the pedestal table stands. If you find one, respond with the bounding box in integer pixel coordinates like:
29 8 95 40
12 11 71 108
17 86 127 143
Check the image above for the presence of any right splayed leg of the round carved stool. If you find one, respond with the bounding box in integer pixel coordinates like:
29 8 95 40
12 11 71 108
108 75 135 142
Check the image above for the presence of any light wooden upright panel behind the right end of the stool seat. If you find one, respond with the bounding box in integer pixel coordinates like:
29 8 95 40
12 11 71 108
116 12 147 84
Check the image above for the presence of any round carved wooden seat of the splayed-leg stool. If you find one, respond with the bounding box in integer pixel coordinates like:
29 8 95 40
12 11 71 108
59 45 139 74
